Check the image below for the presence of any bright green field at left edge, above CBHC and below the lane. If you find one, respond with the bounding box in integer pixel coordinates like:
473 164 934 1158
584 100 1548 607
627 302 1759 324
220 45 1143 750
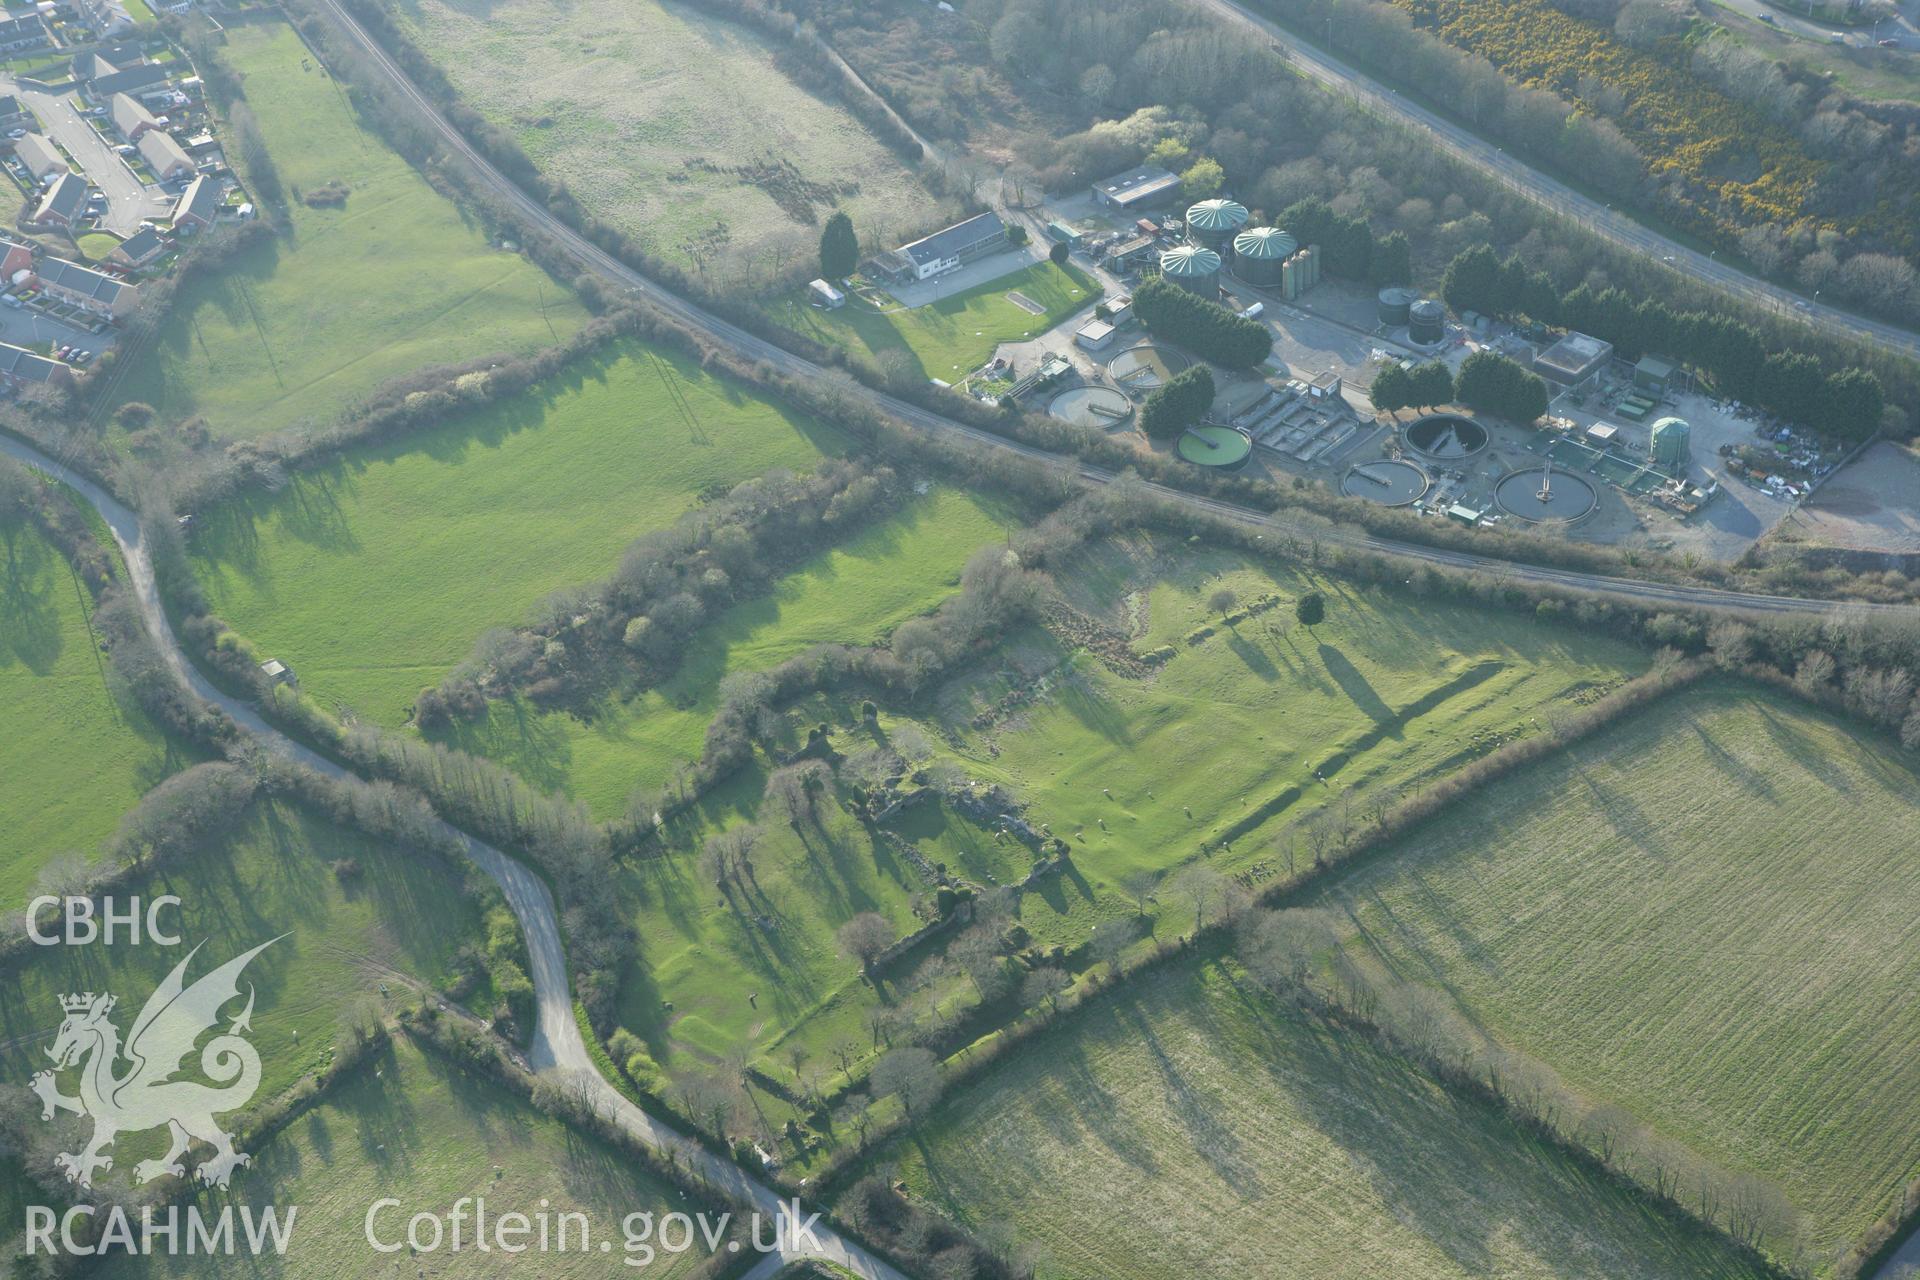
0 528 200 912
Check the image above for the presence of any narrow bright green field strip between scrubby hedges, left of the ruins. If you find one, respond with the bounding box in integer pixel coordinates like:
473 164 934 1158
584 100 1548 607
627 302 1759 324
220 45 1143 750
436 487 1002 819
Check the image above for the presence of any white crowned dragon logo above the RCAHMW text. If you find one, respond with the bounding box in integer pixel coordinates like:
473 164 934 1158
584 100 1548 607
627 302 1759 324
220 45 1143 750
33 935 286 1186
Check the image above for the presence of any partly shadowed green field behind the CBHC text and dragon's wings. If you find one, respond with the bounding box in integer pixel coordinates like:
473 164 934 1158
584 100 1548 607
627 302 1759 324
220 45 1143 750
0 802 482 1105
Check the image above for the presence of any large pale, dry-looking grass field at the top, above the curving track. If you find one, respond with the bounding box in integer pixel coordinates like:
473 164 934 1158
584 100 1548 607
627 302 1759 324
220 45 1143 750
396 0 935 280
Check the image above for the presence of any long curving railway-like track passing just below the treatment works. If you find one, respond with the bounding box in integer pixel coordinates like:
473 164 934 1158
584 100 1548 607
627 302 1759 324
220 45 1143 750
299 0 1920 616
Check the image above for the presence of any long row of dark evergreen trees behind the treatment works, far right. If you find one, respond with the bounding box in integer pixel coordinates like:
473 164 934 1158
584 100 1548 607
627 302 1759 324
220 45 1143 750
1440 244 1885 439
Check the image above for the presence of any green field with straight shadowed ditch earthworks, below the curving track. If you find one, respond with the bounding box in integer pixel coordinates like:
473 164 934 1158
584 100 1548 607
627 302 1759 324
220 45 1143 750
916 535 1645 935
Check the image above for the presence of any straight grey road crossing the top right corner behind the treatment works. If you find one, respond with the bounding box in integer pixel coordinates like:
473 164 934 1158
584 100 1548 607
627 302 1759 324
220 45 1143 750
1190 0 1920 355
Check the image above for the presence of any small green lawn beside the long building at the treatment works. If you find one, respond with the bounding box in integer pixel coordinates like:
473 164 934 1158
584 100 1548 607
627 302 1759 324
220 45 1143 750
770 263 1100 382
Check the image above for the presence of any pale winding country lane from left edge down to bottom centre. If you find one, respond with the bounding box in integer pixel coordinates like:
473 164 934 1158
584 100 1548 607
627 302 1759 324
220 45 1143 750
0 436 906 1280
